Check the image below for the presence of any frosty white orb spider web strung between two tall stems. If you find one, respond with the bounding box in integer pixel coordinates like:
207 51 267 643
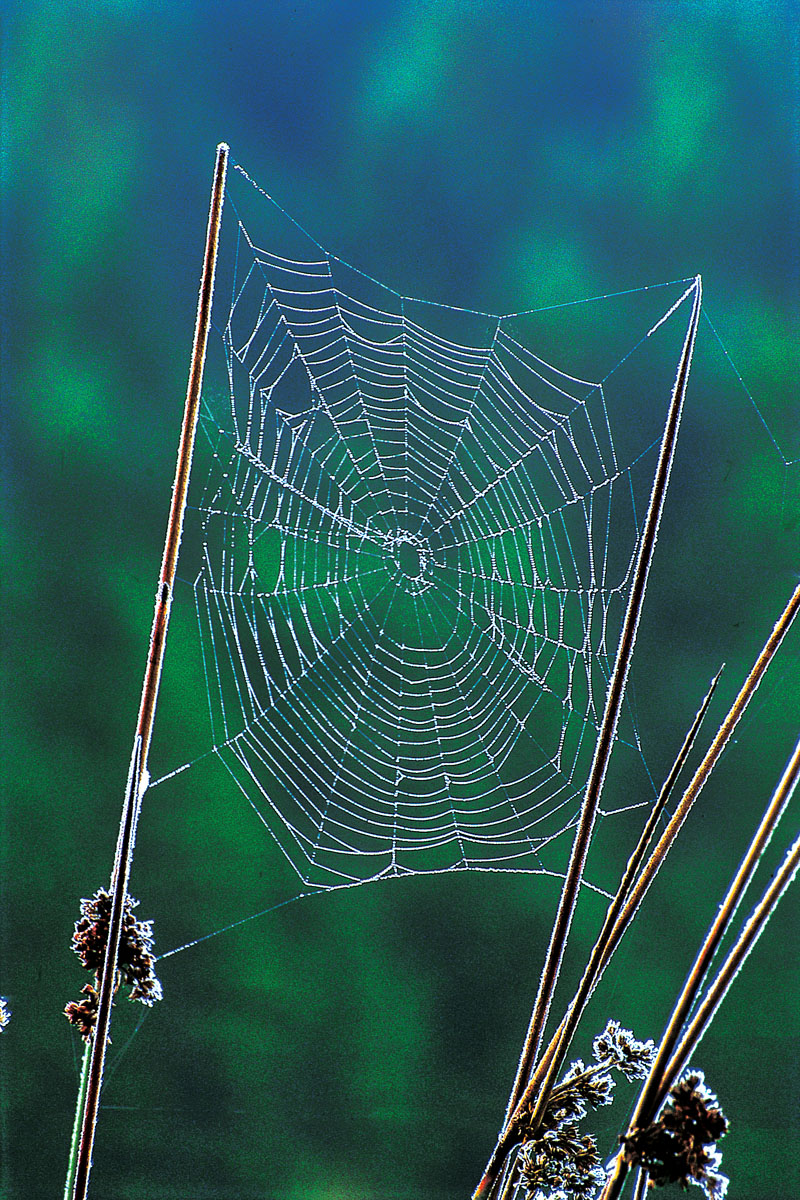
149 169 700 889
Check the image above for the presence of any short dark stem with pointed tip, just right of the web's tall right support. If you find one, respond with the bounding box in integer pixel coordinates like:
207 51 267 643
474 667 723 1195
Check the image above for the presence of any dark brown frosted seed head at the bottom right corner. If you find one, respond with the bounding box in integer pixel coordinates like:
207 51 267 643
620 1070 728 1200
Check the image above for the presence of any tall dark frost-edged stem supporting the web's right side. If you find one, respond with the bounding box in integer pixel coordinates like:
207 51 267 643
474 275 703 1200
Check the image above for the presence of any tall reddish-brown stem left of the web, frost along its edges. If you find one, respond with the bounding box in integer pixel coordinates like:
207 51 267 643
72 144 228 1200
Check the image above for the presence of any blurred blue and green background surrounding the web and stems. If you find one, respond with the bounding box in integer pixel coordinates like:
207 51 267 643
0 0 800 1200
